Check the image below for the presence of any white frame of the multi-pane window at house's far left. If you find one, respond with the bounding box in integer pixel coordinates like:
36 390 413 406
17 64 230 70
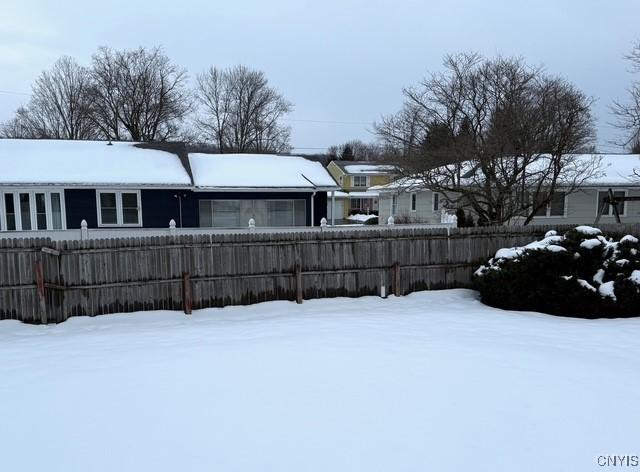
0 187 67 233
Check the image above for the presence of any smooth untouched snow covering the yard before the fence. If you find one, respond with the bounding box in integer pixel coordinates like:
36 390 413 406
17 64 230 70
0 290 640 472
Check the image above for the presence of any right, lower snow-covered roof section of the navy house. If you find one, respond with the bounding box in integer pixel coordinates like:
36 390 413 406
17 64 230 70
189 153 339 190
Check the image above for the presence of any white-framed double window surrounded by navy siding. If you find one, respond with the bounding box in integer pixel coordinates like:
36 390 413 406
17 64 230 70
97 190 142 226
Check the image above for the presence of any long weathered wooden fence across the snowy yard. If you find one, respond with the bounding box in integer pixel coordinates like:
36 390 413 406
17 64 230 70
0 225 640 323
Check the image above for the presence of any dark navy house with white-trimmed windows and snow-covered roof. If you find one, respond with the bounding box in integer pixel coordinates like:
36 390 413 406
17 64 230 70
0 139 338 233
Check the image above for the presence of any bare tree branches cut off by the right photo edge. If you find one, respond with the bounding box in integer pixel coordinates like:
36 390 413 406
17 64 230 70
612 41 640 154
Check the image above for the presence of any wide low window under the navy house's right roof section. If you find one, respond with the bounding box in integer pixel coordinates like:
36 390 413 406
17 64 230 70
200 199 307 228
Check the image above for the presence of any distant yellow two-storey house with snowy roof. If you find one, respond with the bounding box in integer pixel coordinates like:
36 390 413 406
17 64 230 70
327 161 396 219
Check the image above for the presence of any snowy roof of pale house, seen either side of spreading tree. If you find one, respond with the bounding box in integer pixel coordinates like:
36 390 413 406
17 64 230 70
369 154 640 192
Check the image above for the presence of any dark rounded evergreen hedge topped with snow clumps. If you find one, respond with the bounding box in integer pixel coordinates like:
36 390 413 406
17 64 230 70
474 226 640 318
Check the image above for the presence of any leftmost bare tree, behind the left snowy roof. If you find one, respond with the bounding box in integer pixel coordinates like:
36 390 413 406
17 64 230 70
2 56 97 139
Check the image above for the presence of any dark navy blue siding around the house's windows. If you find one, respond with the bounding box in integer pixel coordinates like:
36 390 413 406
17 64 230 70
64 189 327 229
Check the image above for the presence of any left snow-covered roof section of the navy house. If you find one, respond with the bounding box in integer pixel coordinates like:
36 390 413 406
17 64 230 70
0 139 191 186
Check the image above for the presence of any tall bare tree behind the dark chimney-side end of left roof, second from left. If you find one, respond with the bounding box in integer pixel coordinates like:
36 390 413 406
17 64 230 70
91 47 190 141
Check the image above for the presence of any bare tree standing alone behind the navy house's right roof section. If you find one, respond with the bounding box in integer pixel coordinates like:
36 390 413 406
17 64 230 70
195 66 293 152
